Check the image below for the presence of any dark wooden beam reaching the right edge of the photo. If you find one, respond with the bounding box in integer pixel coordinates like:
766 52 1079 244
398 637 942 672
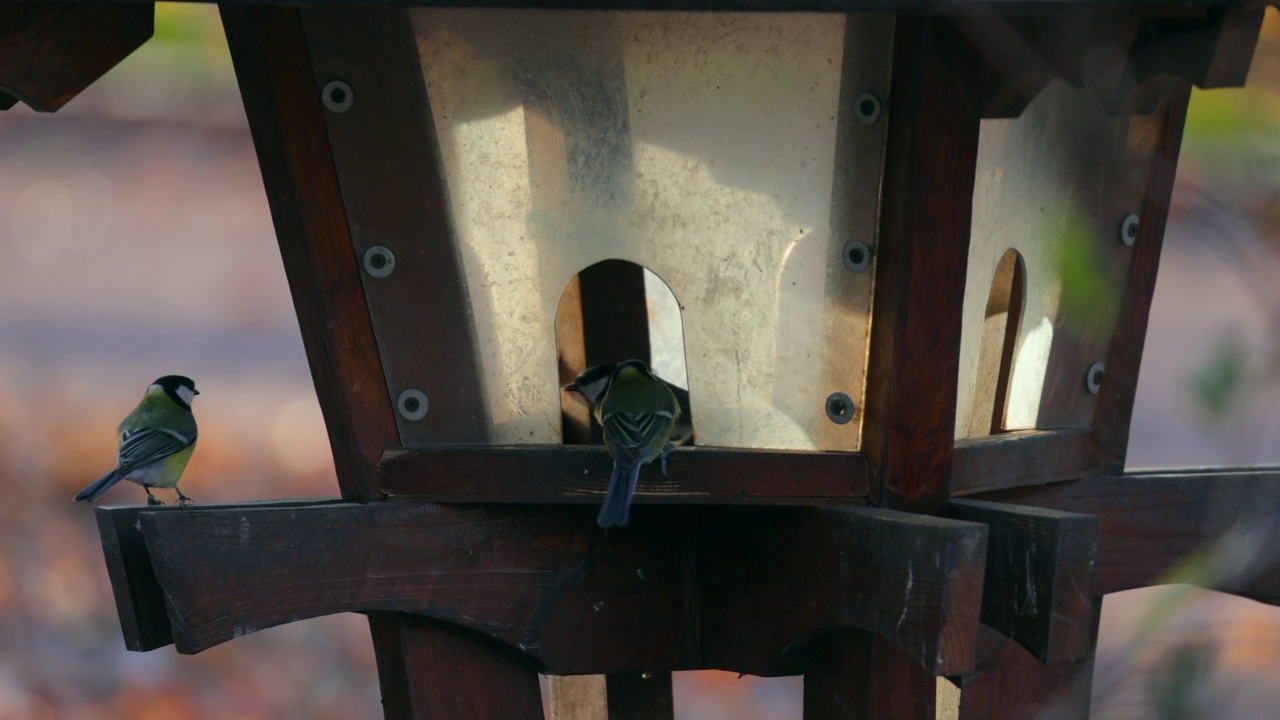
979 468 1280 603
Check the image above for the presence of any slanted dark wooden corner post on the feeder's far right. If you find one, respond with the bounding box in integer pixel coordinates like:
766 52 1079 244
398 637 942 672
1093 85 1190 473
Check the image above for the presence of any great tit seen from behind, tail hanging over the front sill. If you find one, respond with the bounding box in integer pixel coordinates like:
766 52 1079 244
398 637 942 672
584 360 680 528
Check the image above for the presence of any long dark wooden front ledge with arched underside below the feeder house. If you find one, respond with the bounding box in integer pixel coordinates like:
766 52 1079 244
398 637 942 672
99 501 987 675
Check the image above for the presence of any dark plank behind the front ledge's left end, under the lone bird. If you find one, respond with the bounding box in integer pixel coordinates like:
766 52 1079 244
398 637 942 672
93 500 337 652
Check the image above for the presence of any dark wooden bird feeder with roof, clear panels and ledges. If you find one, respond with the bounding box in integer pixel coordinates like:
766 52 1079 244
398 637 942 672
0 0 1280 720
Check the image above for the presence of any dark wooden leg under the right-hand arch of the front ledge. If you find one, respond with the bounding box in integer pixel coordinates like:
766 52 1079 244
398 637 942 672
804 632 937 720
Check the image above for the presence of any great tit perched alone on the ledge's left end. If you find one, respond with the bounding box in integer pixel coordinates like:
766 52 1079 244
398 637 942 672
76 375 200 507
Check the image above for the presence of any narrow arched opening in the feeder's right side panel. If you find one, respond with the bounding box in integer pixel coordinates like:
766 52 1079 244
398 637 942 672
968 249 1027 437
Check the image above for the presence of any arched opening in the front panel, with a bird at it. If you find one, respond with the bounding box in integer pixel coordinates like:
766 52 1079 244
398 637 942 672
556 260 692 445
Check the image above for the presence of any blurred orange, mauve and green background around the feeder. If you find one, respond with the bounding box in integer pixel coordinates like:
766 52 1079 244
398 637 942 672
0 3 1280 720
